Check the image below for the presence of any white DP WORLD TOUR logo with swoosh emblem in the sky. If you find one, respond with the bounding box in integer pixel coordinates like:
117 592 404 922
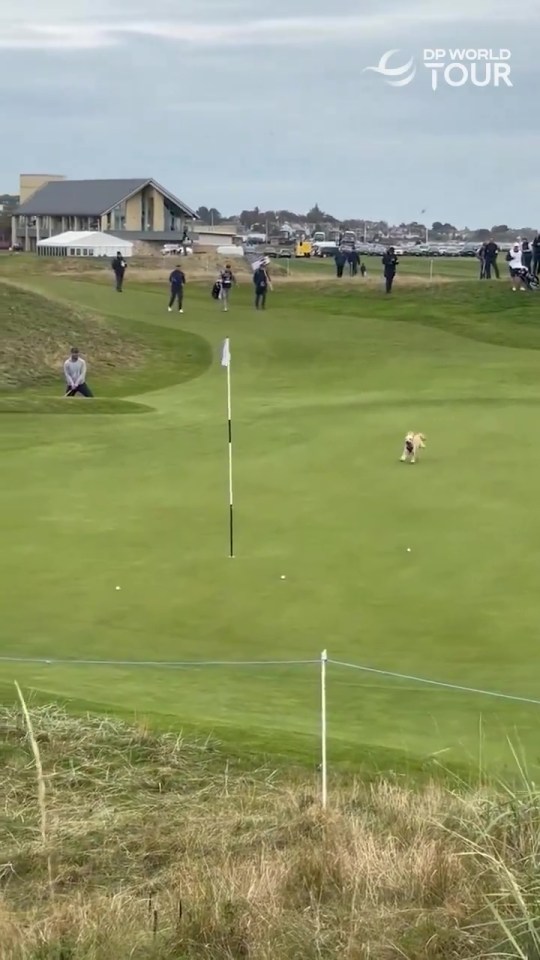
364 47 512 90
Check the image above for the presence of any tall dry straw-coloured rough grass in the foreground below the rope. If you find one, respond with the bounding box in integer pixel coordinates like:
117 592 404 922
0 707 540 960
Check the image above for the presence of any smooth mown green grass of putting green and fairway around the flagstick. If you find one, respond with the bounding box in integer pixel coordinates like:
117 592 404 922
0 264 540 770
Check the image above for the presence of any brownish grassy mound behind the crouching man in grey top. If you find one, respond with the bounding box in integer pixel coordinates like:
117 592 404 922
0 283 212 394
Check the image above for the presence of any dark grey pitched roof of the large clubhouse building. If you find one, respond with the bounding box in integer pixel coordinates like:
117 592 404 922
16 177 198 220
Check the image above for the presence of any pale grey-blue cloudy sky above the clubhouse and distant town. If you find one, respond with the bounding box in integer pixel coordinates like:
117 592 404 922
0 0 540 227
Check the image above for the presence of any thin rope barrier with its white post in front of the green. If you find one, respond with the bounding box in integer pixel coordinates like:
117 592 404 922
4 650 540 809
